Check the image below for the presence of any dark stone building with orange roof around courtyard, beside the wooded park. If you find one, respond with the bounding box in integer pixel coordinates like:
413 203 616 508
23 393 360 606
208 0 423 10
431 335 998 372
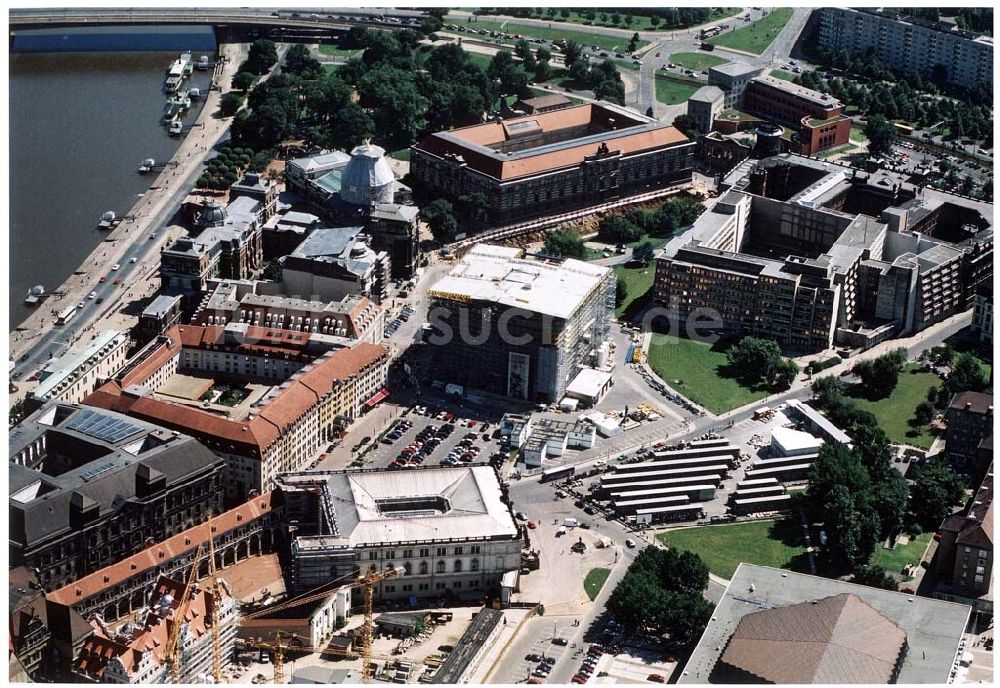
410 102 695 222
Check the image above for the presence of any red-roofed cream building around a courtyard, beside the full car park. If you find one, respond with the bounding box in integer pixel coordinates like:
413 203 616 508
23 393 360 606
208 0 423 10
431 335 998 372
87 323 388 504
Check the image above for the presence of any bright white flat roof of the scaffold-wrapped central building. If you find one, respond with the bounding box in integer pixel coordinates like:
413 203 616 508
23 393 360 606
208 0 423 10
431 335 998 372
430 244 611 318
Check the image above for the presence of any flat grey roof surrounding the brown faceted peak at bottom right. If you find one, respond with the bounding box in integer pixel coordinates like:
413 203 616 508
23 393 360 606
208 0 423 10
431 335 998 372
678 564 972 684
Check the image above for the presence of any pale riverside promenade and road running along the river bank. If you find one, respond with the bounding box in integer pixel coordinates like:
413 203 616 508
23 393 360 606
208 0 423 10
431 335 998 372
9 44 246 370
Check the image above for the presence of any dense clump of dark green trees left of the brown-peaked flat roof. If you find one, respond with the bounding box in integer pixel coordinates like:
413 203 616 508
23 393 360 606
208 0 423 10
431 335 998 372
607 546 714 645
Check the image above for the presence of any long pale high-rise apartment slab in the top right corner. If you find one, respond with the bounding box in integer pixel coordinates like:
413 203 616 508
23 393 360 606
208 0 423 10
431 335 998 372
817 7 993 91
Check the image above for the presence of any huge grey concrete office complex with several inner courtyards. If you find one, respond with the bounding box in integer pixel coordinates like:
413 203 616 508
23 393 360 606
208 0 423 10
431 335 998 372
653 154 993 351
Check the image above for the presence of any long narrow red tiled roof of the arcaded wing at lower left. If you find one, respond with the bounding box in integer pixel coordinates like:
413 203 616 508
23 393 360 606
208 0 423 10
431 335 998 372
46 492 275 607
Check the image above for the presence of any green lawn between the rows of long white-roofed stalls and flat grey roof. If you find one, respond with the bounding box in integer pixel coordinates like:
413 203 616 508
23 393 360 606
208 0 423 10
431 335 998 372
656 519 809 579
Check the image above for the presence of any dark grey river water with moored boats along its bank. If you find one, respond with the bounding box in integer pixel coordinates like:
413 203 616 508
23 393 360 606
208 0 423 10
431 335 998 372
8 33 212 329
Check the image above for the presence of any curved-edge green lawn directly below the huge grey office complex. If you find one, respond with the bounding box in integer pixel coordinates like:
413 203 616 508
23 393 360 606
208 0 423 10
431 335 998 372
649 334 767 414
